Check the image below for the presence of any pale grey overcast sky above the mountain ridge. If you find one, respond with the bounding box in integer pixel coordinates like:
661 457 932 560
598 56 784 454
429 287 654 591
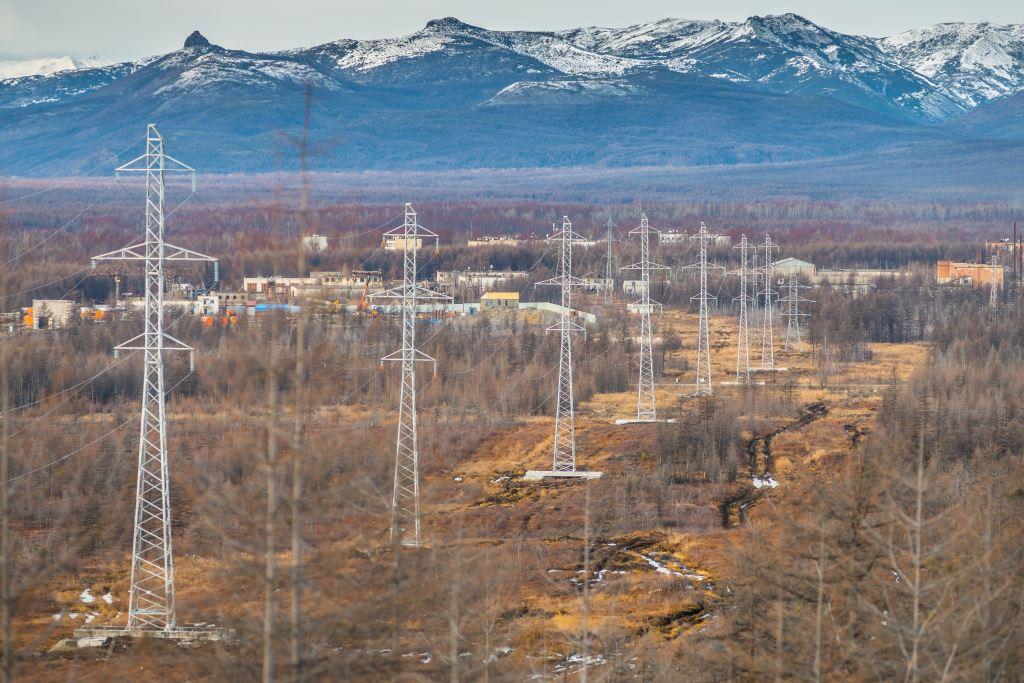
0 0 1024 59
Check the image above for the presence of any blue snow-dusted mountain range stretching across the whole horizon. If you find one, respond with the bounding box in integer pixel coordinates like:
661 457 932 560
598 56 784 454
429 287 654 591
0 14 1024 174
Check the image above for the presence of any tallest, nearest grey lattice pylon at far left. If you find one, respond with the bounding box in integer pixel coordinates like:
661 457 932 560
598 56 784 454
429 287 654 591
92 124 216 631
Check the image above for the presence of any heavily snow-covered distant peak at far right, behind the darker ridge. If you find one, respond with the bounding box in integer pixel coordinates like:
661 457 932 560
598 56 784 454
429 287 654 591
878 23 1024 109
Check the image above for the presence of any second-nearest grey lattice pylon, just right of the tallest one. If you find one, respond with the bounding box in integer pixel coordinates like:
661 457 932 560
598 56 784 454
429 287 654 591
371 204 452 548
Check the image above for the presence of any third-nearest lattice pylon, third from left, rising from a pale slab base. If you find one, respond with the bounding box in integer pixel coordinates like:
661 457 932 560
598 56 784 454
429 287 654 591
538 216 584 472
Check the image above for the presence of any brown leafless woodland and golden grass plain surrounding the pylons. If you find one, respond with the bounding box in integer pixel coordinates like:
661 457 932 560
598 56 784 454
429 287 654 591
0 193 1024 681
